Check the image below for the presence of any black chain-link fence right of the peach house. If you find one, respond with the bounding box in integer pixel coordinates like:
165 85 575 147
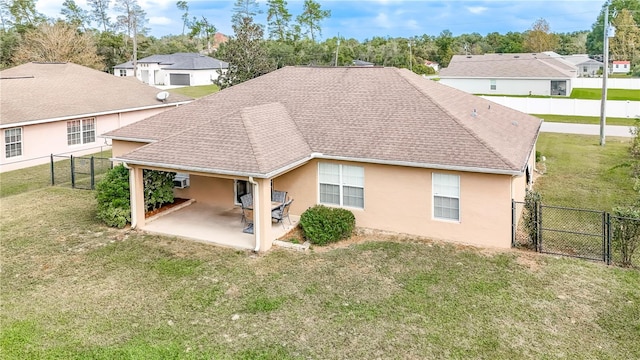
511 201 640 266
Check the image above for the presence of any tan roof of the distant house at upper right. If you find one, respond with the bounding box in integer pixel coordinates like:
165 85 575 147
440 53 577 79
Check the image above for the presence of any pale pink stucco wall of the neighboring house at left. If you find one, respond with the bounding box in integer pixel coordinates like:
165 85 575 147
0 107 173 172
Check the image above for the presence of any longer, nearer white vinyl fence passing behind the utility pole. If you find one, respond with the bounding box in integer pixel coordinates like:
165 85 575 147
481 96 640 118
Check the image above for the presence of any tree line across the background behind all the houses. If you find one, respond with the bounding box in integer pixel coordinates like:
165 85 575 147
0 0 640 86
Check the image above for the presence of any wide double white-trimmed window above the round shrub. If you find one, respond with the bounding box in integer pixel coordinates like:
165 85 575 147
318 162 364 209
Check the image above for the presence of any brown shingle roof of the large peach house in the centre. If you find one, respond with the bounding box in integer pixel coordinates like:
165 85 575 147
106 67 541 176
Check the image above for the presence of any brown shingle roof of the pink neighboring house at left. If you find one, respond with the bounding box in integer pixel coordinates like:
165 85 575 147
0 62 193 125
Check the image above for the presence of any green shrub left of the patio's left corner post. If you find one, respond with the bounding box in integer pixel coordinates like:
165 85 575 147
96 165 131 228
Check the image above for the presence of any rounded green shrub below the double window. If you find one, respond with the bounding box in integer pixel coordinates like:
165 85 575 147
300 205 356 245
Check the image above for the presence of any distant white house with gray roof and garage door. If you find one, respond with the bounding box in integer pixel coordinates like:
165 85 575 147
113 53 229 86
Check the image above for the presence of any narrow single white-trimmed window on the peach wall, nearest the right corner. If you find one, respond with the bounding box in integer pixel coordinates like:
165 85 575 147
433 173 460 221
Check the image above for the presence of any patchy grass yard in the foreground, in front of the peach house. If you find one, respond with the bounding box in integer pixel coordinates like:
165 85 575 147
0 186 640 359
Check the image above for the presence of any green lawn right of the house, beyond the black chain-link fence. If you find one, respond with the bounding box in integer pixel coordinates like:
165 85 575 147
535 133 638 211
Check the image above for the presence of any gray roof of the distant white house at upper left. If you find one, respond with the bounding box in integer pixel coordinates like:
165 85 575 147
113 53 229 70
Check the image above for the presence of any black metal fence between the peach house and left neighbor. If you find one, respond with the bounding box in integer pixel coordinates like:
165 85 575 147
51 154 113 190
